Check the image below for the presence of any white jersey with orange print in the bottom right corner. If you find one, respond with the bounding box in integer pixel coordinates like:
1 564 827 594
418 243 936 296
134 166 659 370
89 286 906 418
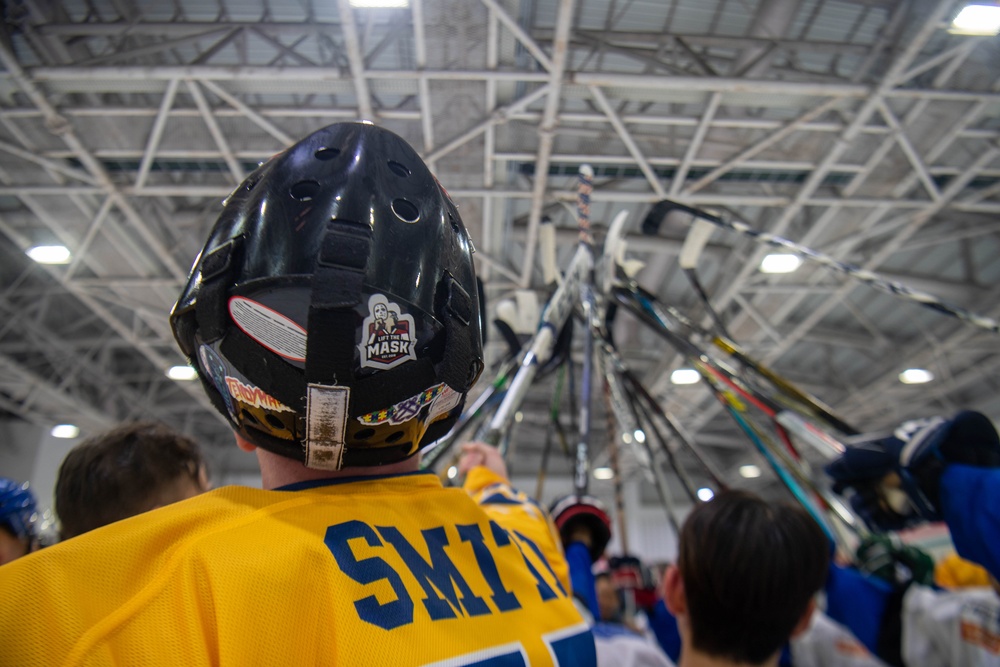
902 584 1000 667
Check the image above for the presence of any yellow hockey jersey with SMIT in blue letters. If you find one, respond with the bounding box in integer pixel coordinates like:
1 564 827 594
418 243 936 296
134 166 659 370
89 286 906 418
0 468 596 667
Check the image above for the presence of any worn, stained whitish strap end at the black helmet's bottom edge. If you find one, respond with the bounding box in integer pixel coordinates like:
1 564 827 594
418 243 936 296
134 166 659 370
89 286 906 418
305 384 351 470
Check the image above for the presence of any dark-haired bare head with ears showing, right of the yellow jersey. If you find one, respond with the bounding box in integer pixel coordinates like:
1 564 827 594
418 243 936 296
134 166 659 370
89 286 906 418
665 490 830 664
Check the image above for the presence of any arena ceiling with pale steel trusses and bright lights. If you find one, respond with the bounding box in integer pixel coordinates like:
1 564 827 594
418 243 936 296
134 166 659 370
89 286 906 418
0 0 1000 508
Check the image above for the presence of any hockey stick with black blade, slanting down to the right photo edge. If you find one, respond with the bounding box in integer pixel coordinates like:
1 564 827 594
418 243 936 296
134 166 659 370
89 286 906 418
643 199 1000 333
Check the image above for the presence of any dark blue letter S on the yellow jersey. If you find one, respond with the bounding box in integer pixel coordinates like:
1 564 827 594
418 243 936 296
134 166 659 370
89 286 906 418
323 521 413 630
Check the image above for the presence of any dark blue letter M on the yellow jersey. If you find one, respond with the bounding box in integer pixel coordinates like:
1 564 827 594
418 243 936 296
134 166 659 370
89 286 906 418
376 526 490 621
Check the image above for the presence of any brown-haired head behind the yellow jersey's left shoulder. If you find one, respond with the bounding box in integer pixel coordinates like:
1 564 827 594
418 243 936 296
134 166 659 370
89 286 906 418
55 422 208 539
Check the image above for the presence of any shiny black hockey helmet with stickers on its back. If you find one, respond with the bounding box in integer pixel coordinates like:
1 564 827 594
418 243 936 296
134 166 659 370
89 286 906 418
170 123 483 470
